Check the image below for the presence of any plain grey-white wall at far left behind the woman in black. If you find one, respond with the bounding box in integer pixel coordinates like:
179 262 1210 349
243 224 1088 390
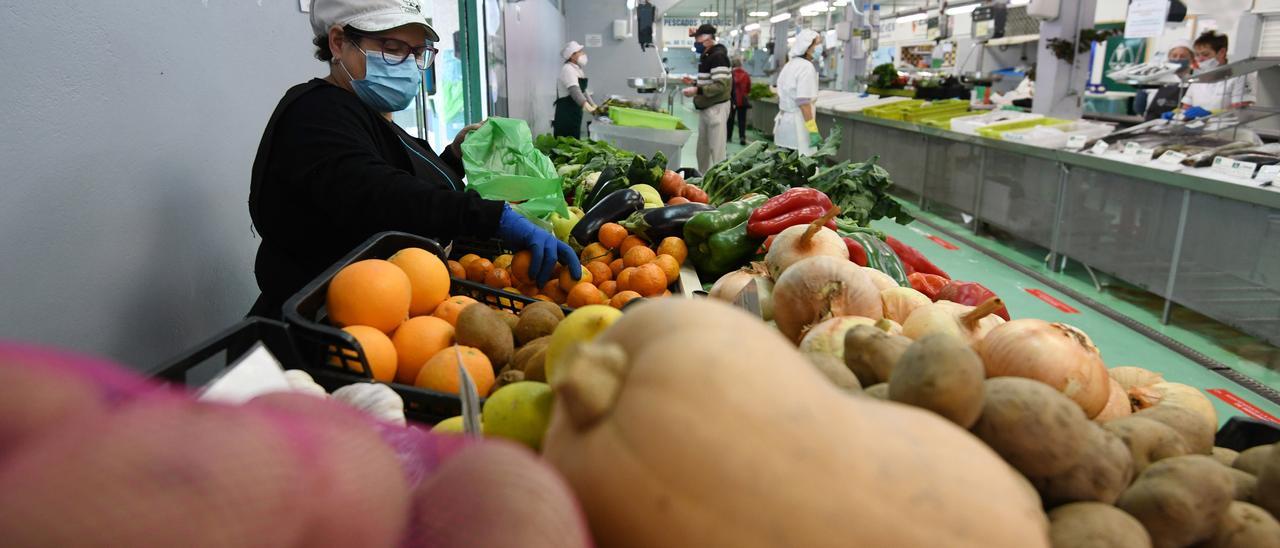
0 0 324 367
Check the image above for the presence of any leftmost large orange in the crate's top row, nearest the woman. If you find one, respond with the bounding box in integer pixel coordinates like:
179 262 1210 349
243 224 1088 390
325 259 413 333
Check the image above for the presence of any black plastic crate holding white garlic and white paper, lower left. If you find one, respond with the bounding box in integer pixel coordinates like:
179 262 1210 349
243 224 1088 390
147 318 306 388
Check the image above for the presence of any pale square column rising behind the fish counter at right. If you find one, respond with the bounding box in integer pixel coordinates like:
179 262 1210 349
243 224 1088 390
1032 0 1097 119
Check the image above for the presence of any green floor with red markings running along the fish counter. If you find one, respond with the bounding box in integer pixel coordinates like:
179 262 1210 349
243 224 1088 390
676 105 1280 421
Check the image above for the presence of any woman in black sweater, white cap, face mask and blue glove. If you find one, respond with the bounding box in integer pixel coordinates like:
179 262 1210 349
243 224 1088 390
250 0 581 318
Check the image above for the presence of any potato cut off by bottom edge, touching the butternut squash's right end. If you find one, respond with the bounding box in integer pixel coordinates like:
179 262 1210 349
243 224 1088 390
1048 502 1151 548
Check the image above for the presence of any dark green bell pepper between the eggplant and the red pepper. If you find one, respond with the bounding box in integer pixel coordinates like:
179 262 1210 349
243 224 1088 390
685 195 769 277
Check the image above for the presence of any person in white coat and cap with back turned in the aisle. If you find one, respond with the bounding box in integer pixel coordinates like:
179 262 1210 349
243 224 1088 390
773 28 822 155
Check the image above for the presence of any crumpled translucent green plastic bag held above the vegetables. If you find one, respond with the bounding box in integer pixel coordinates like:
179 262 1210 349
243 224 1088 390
462 118 568 230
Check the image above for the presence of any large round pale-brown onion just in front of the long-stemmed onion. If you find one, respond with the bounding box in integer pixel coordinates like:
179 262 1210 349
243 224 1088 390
773 256 884 343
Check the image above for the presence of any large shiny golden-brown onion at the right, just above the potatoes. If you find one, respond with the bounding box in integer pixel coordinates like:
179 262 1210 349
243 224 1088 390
977 319 1111 419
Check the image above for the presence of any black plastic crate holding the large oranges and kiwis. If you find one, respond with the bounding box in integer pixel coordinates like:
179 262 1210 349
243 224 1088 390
284 232 560 424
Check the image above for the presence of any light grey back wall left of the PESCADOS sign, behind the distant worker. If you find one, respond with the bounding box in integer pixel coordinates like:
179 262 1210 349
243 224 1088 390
564 0 677 101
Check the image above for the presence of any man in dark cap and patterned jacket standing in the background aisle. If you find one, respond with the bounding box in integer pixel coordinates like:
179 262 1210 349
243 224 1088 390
685 24 733 173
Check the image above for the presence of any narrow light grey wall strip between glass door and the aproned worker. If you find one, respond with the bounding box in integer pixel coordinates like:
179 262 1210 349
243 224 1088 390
503 0 565 136
